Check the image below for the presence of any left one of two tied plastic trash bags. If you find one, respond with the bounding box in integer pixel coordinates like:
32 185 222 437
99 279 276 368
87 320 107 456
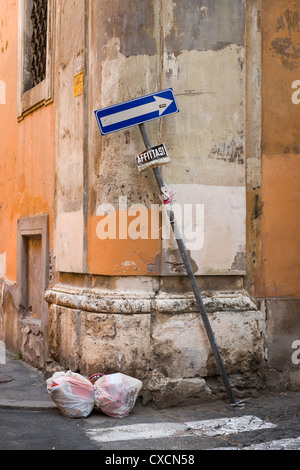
46 371 95 418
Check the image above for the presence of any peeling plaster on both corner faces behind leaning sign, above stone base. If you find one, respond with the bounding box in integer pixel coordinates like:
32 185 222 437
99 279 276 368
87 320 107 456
87 1 246 275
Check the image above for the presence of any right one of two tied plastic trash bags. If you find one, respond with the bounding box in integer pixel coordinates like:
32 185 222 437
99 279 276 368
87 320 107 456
94 372 142 418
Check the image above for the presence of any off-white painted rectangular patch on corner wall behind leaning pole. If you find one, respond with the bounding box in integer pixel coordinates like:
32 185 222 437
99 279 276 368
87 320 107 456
162 184 246 275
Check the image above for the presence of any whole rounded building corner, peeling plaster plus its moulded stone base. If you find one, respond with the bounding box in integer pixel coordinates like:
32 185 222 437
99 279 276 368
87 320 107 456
46 0 264 405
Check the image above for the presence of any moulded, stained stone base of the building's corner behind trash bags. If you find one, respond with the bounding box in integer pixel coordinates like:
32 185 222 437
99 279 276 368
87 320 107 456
46 285 264 407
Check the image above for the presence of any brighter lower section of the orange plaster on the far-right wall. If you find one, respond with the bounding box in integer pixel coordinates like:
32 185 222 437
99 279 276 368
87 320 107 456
262 154 300 297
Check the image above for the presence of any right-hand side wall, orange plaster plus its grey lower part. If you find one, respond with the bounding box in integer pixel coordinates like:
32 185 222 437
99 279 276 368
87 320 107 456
256 0 300 387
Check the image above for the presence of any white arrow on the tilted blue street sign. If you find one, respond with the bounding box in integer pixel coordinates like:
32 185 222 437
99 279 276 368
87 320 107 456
100 96 173 127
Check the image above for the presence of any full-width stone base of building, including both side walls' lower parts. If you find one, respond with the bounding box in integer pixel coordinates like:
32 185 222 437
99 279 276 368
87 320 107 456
0 279 300 407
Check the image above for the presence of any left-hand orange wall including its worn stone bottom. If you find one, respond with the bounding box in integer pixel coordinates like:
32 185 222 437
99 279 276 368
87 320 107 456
0 0 55 367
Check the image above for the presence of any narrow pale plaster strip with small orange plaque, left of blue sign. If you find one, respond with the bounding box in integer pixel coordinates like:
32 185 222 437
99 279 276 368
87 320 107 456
55 0 85 273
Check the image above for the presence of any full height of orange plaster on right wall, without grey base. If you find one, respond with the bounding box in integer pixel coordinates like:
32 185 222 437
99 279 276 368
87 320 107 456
257 0 300 297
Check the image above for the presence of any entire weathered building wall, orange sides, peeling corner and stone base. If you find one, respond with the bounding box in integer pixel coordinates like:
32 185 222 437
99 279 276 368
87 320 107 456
0 0 300 405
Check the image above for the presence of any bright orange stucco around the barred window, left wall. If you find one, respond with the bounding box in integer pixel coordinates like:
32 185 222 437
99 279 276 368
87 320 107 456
0 0 55 281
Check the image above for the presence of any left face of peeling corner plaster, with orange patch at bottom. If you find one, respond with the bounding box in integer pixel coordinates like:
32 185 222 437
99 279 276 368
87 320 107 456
87 0 161 276
